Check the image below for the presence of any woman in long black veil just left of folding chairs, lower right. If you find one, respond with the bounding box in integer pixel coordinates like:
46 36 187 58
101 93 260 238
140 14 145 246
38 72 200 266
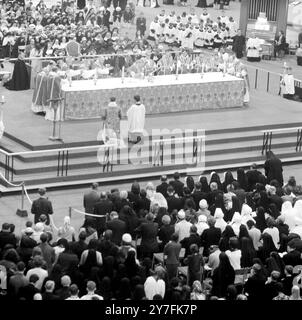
211 252 235 298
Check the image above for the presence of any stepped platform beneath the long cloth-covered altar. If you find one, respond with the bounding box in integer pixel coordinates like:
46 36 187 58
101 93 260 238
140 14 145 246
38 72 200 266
0 84 302 192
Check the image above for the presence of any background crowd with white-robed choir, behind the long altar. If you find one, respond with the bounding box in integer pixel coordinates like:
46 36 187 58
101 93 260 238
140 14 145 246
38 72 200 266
0 0 245 58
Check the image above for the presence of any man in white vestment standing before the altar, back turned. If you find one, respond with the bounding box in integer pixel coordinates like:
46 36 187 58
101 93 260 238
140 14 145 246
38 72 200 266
127 95 146 143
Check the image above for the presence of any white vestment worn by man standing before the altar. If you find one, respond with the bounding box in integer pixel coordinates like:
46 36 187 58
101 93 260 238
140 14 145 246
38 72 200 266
127 102 146 136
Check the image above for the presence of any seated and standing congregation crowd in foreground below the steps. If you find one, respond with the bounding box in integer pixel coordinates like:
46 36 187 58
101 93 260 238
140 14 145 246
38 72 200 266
0 152 302 301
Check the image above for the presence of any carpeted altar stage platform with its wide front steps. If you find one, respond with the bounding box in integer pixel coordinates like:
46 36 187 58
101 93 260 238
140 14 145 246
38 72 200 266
0 84 302 188
